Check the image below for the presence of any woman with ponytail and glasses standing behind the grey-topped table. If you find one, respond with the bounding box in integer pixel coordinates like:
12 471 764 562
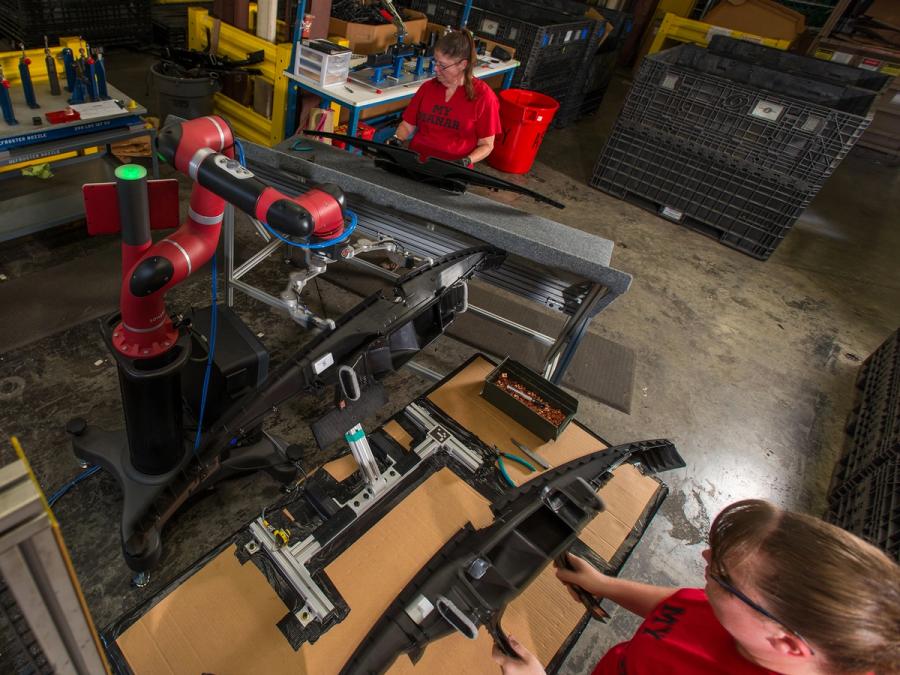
388 30 500 167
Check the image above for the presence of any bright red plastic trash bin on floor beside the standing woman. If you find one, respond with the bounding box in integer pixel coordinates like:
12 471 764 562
487 89 559 173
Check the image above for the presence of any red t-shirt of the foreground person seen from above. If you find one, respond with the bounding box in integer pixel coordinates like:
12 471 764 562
593 588 775 675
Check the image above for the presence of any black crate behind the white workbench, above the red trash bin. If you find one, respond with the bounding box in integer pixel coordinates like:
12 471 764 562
406 0 598 116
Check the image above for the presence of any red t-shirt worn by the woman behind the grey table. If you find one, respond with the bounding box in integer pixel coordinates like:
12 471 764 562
403 78 500 160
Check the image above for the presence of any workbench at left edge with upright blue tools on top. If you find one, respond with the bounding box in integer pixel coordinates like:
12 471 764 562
0 84 159 241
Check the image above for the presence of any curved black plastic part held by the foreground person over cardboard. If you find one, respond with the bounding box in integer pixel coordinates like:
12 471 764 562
341 440 684 675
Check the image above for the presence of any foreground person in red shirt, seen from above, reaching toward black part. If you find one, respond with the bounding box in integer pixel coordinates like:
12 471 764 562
493 500 900 675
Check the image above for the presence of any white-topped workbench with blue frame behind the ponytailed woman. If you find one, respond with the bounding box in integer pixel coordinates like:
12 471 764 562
284 60 519 136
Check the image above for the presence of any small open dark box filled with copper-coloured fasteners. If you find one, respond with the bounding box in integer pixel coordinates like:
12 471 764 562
481 358 578 441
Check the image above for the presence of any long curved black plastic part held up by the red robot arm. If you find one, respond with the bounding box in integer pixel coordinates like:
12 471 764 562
124 246 505 569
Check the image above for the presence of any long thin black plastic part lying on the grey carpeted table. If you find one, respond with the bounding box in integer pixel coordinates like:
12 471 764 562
303 130 566 209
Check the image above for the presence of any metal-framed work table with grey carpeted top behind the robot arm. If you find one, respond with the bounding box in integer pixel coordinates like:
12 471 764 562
224 139 631 382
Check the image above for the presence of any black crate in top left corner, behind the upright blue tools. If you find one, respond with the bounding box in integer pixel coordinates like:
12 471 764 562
0 0 151 47
